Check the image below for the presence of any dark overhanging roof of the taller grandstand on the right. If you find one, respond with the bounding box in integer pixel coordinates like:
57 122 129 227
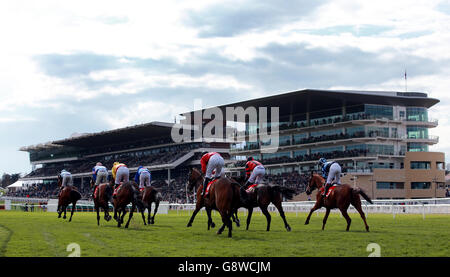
181 89 439 119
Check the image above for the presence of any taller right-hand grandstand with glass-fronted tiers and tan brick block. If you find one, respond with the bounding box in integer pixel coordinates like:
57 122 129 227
184 89 445 200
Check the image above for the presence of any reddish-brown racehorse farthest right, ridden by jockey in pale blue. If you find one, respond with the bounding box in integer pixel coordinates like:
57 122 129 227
305 172 373 232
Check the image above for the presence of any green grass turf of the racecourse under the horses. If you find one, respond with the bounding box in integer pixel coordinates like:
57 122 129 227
0 211 450 257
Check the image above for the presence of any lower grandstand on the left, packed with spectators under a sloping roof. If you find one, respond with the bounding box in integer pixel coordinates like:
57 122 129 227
20 122 230 200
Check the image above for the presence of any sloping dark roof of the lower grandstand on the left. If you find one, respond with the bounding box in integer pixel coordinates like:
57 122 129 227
20 121 173 151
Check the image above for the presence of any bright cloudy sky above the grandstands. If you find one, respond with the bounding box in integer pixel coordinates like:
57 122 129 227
0 0 450 175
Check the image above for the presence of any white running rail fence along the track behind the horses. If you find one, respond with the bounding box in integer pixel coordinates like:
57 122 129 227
0 194 450 217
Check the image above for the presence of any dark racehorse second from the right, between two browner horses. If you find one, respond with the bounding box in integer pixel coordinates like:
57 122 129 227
235 176 295 232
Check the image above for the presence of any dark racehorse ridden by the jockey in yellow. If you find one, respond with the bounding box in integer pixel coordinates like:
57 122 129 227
113 181 147 228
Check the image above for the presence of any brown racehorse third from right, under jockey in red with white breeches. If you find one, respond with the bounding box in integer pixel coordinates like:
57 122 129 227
187 168 240 237
